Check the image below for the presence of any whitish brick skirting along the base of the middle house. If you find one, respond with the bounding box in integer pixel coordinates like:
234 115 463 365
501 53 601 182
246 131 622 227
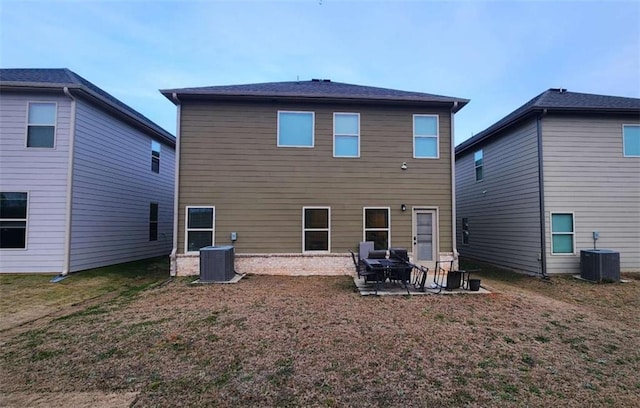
172 252 458 276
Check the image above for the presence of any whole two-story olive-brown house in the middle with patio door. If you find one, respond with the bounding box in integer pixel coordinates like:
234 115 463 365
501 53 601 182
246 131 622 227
161 80 468 275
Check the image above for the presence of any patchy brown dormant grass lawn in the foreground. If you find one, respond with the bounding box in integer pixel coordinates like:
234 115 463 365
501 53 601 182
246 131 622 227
0 265 640 407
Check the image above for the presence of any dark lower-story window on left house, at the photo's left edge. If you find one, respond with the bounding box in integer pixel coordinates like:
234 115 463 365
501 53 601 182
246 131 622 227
0 192 27 249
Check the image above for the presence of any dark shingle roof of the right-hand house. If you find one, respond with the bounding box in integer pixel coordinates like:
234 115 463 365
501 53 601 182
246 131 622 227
456 88 640 154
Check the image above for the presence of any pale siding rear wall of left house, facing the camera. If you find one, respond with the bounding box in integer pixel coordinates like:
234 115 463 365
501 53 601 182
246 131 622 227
0 93 71 273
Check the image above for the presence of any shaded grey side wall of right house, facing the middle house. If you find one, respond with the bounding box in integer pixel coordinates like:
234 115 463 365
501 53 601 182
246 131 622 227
456 119 540 273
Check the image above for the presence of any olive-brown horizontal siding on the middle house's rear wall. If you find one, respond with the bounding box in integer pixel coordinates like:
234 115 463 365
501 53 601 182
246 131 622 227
178 102 452 253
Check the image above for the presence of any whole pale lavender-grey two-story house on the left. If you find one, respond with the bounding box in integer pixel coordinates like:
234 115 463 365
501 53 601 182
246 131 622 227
0 69 175 274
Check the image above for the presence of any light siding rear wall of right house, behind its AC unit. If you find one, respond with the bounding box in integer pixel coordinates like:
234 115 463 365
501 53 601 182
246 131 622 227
543 116 640 273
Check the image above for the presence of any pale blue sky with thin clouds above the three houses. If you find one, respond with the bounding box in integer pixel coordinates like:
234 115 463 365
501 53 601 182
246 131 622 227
0 0 640 143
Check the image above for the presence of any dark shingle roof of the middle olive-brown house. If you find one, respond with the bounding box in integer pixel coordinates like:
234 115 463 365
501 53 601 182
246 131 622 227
160 79 469 111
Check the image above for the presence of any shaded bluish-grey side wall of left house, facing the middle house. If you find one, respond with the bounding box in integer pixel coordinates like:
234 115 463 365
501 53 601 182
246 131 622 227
71 99 175 271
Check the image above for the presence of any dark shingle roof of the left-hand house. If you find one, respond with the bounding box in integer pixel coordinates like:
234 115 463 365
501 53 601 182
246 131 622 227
0 68 175 145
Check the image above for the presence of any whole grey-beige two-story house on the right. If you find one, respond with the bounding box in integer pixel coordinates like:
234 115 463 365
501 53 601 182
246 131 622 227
456 89 640 274
